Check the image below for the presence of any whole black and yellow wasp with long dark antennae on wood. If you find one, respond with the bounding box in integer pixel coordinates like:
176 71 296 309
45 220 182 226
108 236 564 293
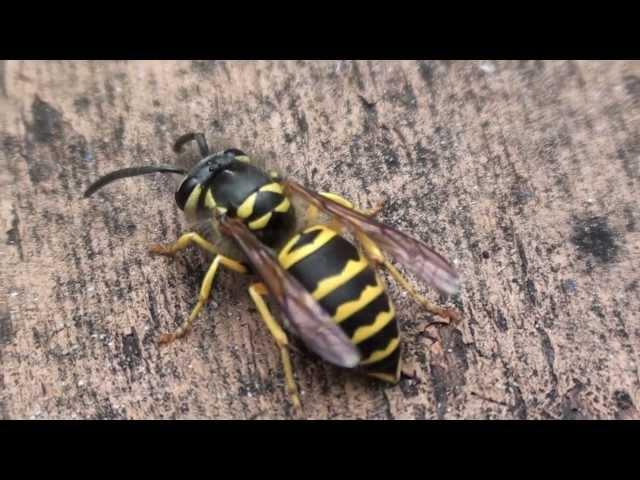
85 133 459 407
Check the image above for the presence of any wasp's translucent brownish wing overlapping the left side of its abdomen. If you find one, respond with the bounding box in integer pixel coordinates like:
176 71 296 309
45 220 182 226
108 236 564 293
220 216 360 368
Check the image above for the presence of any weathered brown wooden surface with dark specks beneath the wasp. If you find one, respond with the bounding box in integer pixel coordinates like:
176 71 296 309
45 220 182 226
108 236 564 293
0 61 640 419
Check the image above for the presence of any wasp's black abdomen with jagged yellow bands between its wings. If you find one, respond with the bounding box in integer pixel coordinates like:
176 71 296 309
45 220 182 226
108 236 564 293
278 225 401 382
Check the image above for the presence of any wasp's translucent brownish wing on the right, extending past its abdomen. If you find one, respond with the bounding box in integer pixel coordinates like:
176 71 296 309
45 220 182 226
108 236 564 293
285 180 460 294
